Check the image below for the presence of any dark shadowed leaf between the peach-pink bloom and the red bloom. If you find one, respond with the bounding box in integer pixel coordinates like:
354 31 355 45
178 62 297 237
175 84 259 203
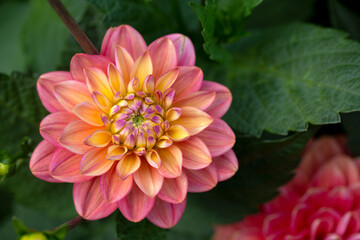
174 128 316 236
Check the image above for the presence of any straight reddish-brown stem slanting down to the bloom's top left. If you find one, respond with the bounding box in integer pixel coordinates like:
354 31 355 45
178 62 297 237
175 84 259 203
48 0 99 54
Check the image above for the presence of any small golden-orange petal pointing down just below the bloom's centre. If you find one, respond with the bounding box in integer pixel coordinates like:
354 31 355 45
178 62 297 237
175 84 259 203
116 153 141 180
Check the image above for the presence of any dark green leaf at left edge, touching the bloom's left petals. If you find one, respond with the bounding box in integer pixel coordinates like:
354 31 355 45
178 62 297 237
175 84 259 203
0 72 46 152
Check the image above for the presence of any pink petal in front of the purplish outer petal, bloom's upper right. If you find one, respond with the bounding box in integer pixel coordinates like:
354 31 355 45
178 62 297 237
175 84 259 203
148 37 177 79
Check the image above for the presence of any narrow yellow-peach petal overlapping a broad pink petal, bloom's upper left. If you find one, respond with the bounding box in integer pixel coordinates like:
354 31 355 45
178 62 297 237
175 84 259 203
84 67 114 100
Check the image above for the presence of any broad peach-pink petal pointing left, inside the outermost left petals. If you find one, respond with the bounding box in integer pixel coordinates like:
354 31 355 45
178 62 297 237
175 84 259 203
59 120 101 154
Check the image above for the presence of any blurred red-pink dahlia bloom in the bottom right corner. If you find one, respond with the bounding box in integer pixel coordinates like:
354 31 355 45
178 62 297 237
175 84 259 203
213 137 360 240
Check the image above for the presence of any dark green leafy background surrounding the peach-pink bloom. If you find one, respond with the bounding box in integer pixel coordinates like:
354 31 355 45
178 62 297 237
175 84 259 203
0 0 360 240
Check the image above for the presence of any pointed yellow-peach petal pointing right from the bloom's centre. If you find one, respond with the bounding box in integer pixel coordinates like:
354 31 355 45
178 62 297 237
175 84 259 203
172 107 213 136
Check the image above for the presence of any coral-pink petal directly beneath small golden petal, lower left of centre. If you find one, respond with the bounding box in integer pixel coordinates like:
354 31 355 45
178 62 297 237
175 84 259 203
100 165 133 203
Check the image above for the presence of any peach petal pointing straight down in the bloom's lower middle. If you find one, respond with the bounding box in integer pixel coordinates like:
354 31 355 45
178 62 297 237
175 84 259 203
133 161 164 198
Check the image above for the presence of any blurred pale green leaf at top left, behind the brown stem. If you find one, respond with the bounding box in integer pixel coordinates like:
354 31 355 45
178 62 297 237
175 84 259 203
22 0 87 73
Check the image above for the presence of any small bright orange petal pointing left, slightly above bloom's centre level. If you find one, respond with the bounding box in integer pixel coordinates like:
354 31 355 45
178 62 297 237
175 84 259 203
73 102 104 127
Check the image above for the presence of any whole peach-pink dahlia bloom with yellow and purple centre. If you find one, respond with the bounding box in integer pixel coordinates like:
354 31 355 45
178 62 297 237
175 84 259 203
30 25 238 228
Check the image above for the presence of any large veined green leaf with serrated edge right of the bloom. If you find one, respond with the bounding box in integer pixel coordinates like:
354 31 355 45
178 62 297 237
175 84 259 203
224 23 360 136
